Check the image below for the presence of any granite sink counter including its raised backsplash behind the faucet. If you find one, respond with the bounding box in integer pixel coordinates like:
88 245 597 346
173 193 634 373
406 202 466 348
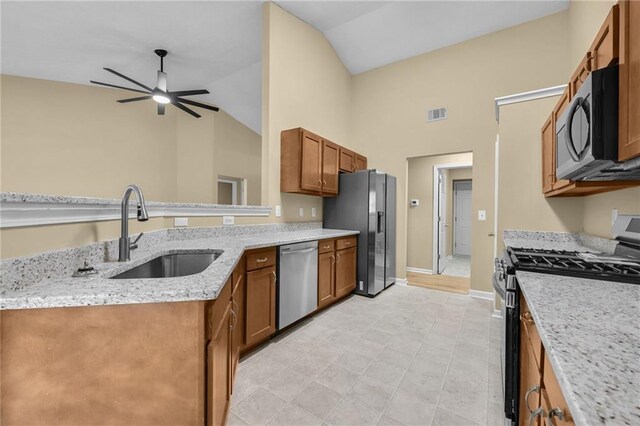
0 223 358 310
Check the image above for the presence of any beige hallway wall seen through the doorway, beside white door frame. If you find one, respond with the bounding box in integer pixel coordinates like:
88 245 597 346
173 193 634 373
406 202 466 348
403 153 473 270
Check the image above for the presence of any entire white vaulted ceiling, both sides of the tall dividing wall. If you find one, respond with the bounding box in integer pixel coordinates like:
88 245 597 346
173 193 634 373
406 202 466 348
1 0 568 133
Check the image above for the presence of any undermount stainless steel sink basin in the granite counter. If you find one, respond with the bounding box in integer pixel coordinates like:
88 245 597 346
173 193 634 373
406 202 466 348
111 251 222 280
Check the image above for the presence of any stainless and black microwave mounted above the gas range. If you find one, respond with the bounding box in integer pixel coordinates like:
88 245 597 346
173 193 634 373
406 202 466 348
556 66 618 180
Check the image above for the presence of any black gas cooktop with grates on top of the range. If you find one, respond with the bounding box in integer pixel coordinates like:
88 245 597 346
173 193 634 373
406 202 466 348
507 247 640 284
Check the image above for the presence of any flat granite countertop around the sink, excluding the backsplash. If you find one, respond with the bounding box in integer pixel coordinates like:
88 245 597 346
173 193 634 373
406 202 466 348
0 227 358 310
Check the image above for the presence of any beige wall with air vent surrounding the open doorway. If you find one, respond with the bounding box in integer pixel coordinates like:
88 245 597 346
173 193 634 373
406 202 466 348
351 12 568 291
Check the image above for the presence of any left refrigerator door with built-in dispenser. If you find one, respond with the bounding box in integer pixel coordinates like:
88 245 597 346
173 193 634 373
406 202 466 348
369 172 387 295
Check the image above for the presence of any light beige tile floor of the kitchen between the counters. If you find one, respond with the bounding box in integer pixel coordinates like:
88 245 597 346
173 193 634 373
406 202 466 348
228 285 504 426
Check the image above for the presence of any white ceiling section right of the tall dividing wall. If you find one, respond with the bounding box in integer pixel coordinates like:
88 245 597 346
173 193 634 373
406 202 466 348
277 0 569 74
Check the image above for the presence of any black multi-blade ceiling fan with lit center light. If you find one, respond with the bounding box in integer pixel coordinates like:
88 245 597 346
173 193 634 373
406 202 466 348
90 49 219 118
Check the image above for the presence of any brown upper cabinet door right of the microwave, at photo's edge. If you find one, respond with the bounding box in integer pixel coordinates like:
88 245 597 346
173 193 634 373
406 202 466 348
618 0 640 161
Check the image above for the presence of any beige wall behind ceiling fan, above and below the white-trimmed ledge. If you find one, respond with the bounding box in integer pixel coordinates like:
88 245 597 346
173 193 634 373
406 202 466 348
0 75 264 258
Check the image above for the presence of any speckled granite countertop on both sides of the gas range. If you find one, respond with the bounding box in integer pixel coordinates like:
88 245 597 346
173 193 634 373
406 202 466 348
504 231 640 425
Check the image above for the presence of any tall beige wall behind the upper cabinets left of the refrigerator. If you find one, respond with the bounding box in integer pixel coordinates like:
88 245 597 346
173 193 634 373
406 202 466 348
262 3 351 221
